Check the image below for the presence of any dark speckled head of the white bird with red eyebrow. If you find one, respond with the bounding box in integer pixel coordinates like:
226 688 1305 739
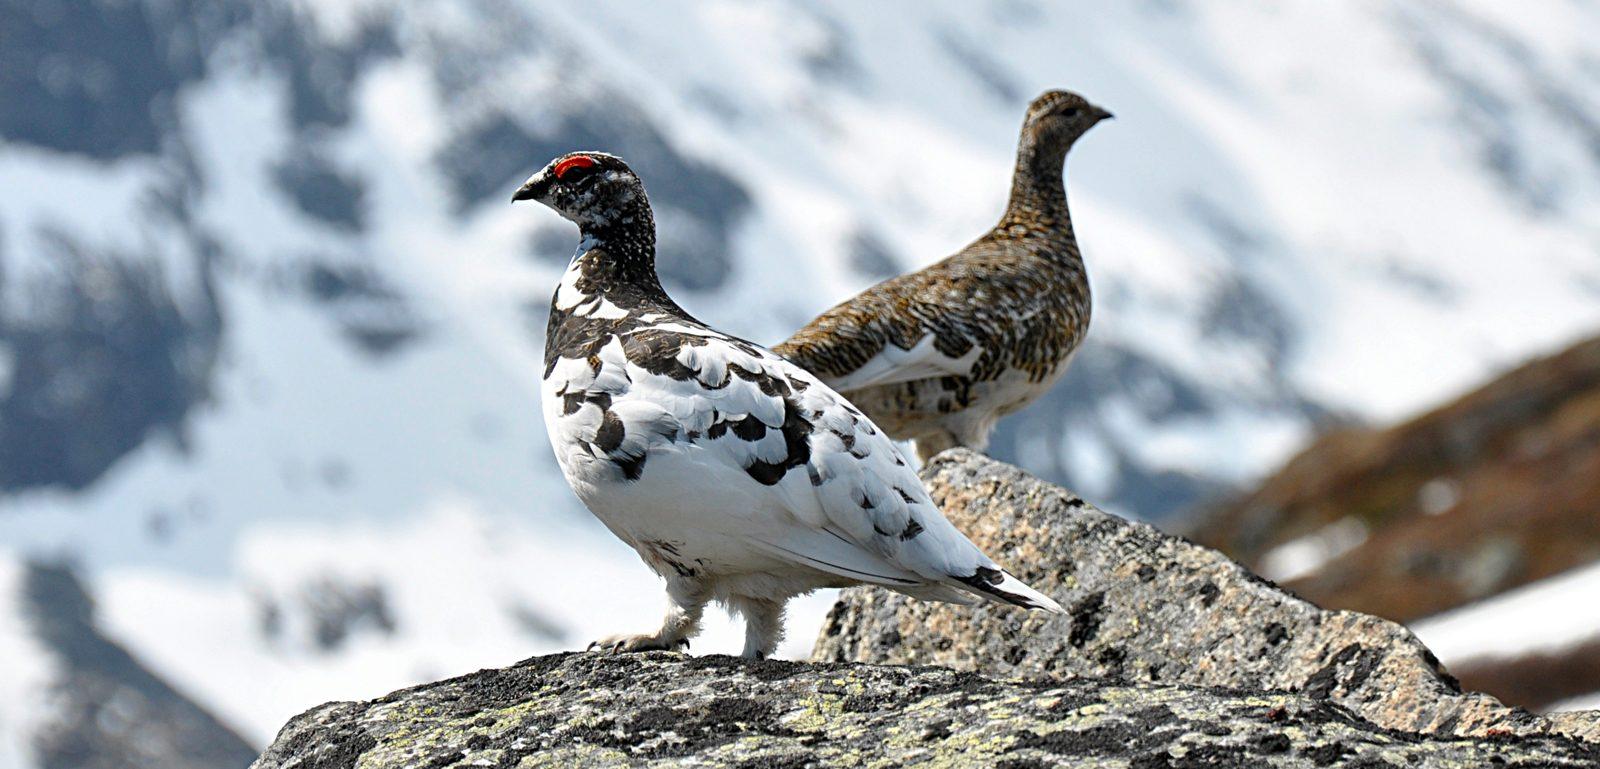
510 152 650 229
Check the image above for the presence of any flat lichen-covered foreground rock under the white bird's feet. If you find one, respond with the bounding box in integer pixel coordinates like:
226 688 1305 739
254 652 1600 769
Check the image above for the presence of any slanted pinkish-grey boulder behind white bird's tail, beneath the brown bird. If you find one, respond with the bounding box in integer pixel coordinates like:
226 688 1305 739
813 449 1600 742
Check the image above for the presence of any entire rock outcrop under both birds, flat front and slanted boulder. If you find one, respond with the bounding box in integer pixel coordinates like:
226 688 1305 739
254 451 1600 769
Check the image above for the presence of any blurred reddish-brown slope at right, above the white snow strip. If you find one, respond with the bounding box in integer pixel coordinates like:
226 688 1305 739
1194 332 1600 620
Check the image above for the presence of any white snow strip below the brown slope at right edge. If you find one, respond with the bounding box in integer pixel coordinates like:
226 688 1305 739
1411 564 1600 665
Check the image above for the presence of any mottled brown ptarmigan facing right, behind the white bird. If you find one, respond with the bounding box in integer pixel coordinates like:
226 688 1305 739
773 90 1112 462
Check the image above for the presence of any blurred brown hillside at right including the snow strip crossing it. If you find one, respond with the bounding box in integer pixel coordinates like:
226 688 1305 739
1190 326 1600 710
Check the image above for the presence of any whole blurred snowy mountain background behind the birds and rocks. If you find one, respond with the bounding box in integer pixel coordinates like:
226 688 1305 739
0 0 1600 769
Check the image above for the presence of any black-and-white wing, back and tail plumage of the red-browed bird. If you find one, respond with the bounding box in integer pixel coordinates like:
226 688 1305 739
547 315 1061 612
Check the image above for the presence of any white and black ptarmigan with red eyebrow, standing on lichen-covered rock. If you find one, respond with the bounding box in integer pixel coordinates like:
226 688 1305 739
512 152 1061 659
